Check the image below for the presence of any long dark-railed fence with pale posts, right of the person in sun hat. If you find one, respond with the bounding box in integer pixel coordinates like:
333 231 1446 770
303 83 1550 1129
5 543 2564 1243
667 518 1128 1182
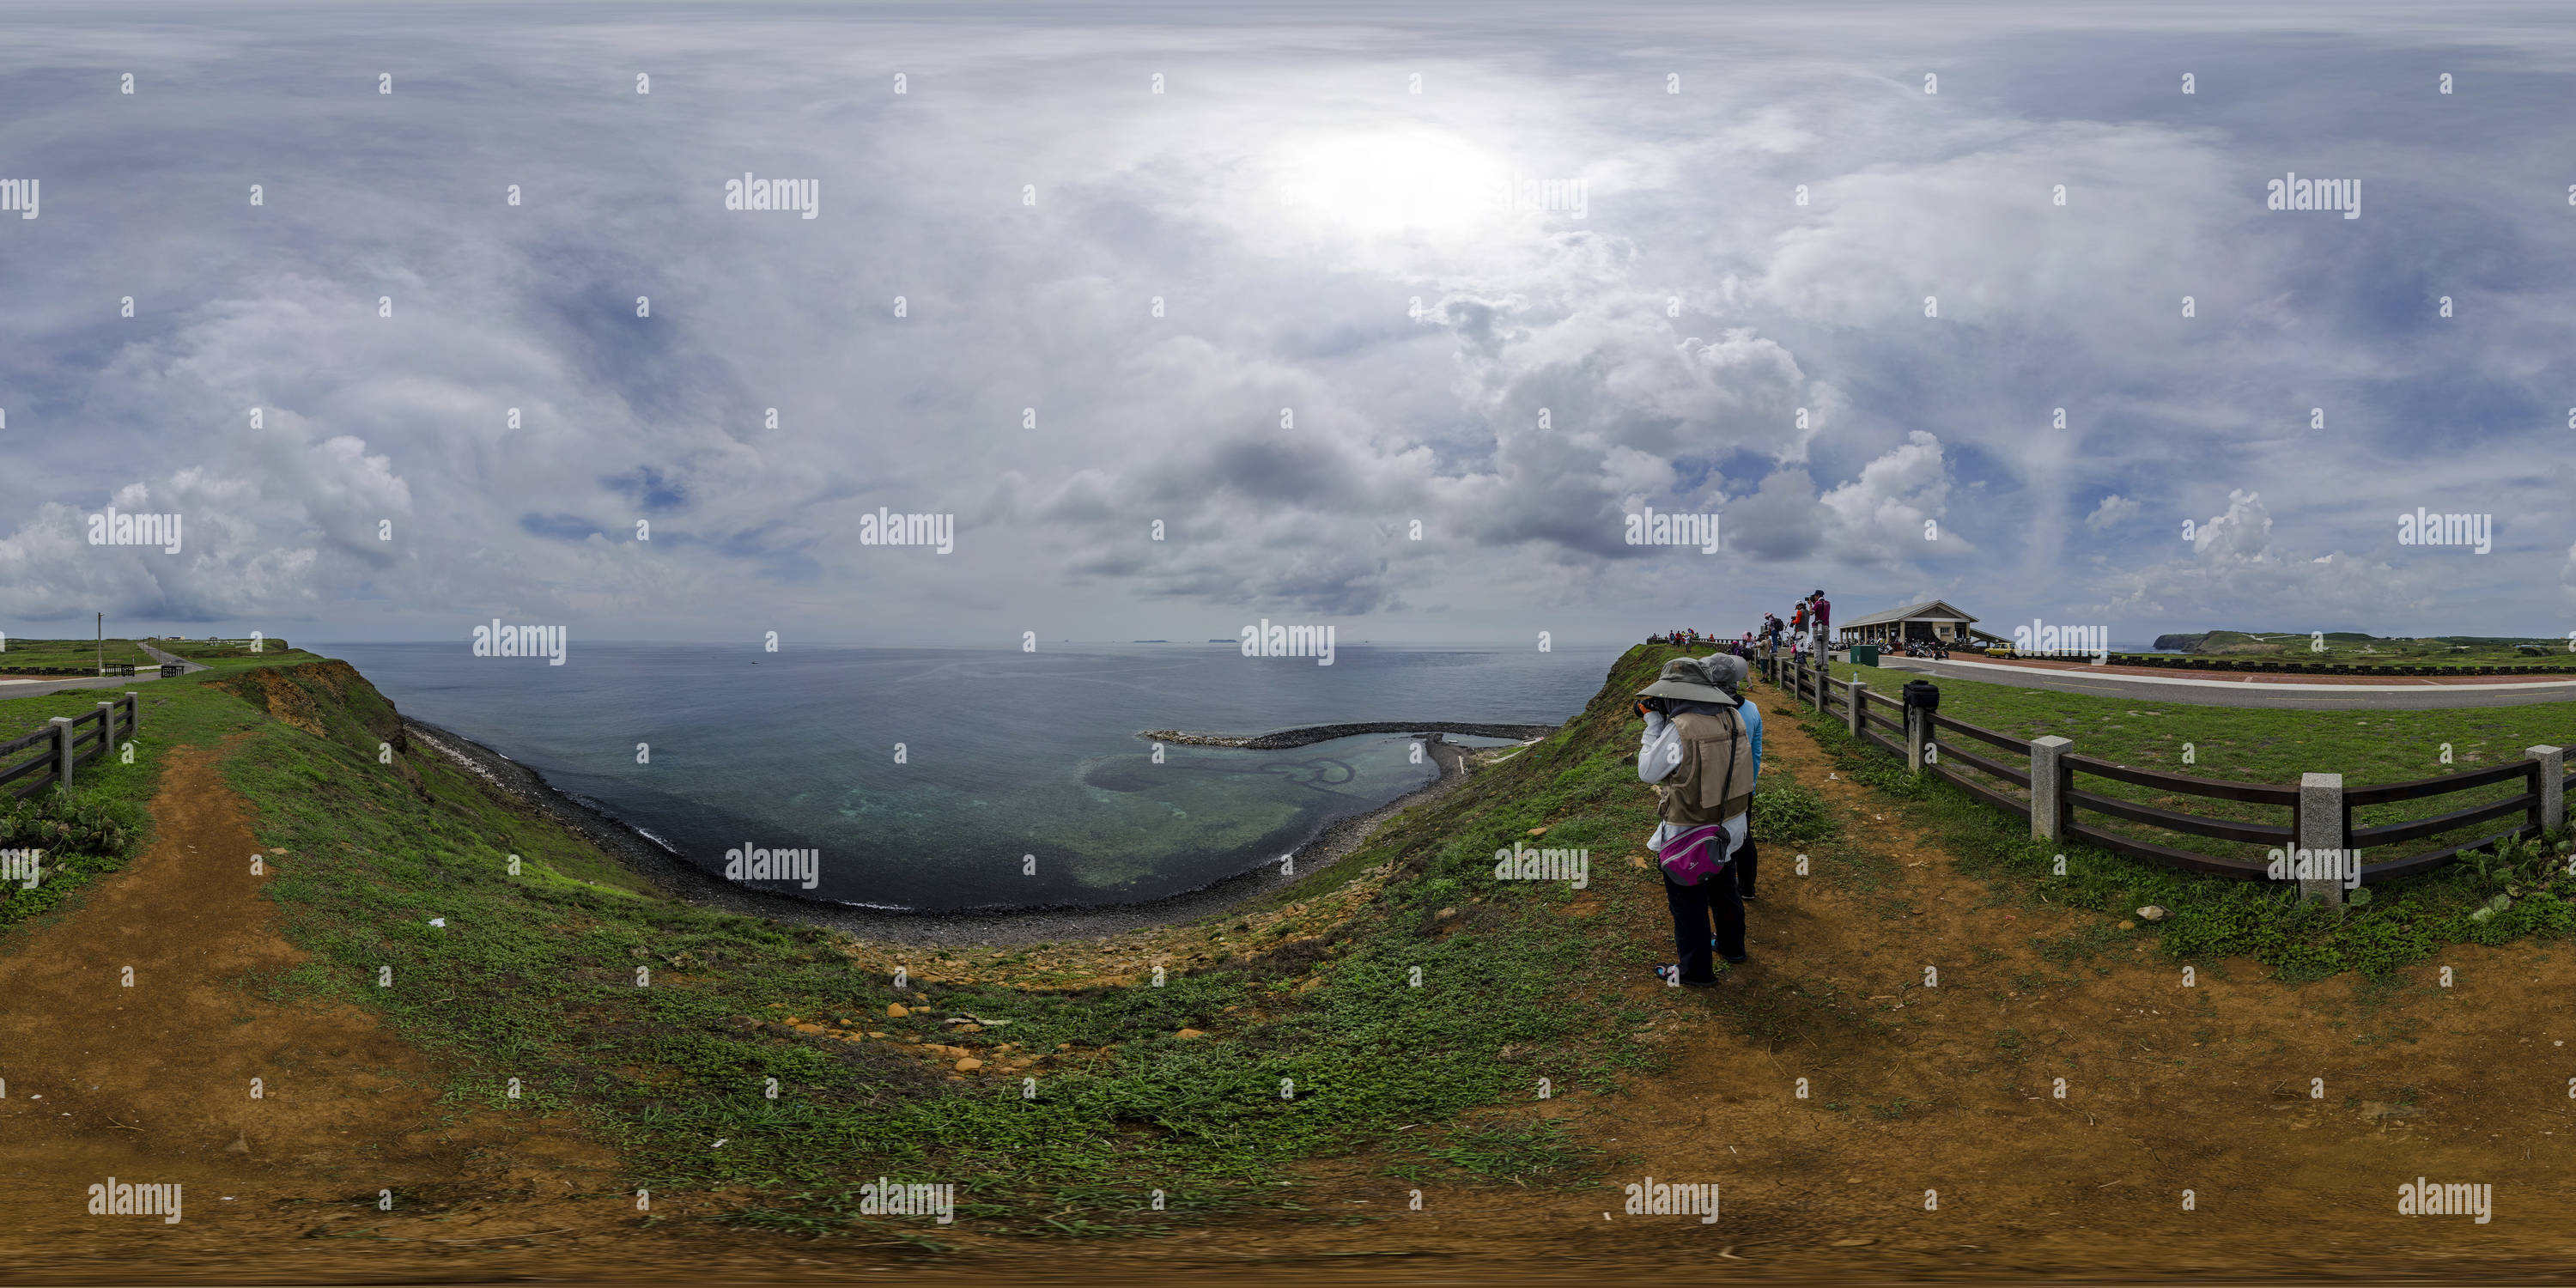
1759 657 2571 891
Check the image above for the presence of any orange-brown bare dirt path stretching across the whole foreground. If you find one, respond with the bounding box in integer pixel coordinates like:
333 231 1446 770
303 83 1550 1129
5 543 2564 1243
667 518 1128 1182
0 711 2576 1283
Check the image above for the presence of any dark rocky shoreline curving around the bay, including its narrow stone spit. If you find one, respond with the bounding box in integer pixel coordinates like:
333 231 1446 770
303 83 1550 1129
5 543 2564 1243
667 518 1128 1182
402 716 1494 948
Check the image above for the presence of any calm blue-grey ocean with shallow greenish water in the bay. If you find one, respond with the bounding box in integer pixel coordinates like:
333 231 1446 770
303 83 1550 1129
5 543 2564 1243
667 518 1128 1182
312 639 1620 912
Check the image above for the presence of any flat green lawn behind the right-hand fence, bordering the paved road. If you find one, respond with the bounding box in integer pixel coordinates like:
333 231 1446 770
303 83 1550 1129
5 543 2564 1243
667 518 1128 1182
1832 665 2576 863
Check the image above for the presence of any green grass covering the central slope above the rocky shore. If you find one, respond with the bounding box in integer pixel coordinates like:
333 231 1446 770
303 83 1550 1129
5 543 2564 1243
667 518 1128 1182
191 654 1674 1236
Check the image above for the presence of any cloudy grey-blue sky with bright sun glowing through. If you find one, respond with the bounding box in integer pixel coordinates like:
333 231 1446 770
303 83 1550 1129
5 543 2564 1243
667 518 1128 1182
0 3 2576 647
